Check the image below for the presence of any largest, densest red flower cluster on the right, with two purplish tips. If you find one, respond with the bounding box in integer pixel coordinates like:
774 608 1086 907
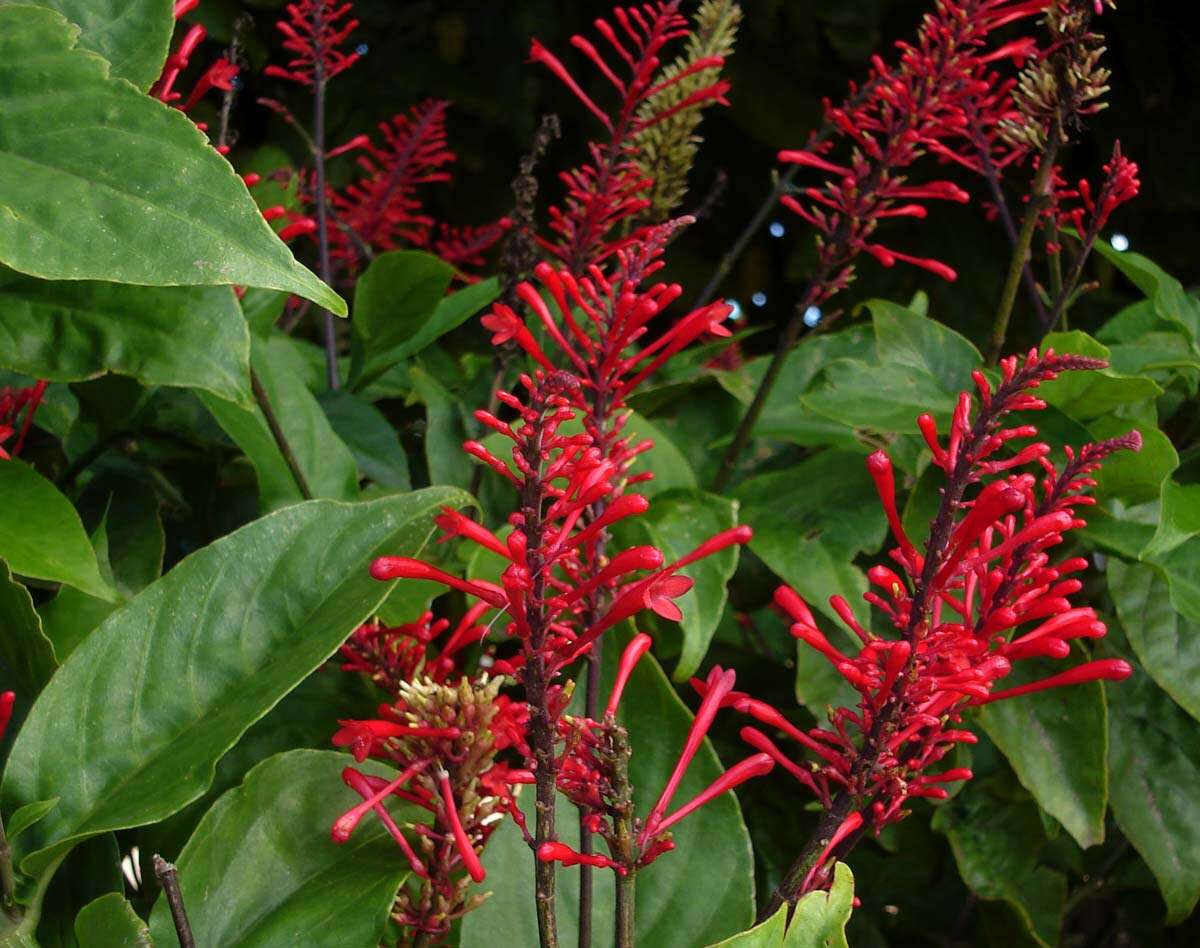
720 350 1141 890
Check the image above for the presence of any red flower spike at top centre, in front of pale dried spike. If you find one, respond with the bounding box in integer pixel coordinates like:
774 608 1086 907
529 0 728 276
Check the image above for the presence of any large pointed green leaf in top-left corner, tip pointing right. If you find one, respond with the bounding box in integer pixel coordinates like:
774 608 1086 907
0 6 346 314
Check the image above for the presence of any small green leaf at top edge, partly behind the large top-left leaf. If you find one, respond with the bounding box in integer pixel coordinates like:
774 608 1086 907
22 0 175 92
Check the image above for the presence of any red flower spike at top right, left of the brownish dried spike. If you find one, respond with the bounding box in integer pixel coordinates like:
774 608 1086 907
779 0 1048 302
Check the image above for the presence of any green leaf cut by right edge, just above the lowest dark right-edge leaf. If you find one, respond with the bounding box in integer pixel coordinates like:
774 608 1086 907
1108 559 1200 720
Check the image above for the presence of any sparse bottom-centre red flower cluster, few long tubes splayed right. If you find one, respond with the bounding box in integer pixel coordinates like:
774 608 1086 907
538 634 775 875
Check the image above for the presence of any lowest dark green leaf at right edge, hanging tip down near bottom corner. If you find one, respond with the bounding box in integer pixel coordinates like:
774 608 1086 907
1109 674 1200 925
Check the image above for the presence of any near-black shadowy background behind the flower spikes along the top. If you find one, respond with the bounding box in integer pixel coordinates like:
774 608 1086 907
198 0 1200 348
